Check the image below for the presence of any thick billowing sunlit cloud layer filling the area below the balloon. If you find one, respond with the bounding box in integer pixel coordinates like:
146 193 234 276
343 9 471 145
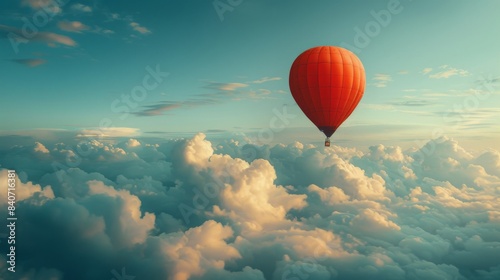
0 134 500 280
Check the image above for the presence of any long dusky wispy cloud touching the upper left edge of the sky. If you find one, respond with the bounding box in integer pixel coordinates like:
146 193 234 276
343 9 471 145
0 25 77 47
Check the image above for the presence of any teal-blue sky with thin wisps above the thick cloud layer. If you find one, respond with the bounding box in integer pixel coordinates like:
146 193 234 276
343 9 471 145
0 0 500 150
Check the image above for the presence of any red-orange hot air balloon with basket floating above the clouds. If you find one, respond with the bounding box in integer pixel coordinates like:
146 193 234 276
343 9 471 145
289 46 365 146
